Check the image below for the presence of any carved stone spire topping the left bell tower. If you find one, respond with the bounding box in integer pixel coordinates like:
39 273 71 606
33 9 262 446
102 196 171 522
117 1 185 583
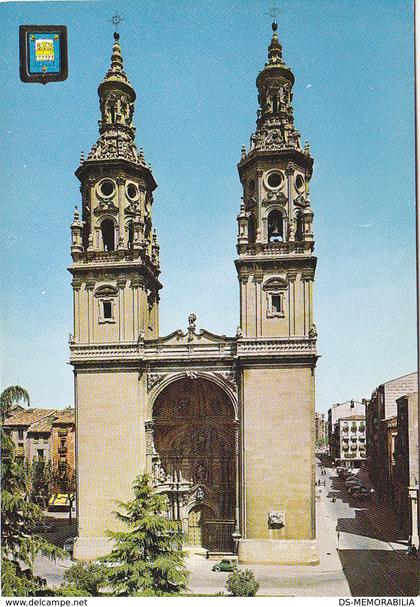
86 32 146 166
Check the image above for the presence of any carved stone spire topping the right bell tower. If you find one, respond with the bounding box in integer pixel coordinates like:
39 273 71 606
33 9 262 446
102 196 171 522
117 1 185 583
244 22 301 155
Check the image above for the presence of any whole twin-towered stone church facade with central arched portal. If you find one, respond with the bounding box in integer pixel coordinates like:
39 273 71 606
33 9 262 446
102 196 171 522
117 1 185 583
70 23 317 564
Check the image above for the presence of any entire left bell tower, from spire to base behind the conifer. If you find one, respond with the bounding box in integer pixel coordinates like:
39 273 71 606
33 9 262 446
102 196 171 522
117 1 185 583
69 33 162 559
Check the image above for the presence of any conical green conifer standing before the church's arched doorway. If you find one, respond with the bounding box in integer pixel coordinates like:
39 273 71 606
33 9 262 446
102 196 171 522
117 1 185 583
101 474 188 596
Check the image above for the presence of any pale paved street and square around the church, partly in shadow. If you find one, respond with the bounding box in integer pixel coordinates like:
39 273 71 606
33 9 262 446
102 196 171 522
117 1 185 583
33 462 419 596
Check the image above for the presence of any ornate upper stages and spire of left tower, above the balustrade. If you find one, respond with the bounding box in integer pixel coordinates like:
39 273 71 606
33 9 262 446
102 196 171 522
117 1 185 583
70 33 162 344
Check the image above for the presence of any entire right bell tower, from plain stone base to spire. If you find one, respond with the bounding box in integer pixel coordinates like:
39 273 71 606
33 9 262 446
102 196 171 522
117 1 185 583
235 23 317 563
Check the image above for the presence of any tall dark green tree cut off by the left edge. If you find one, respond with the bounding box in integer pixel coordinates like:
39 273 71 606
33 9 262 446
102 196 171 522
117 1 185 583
0 386 63 596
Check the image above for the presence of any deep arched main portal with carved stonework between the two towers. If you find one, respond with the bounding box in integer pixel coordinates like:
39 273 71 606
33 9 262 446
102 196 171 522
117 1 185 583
148 378 237 552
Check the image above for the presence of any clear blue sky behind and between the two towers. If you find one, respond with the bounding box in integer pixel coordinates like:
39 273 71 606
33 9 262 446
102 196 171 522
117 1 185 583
0 0 416 411
